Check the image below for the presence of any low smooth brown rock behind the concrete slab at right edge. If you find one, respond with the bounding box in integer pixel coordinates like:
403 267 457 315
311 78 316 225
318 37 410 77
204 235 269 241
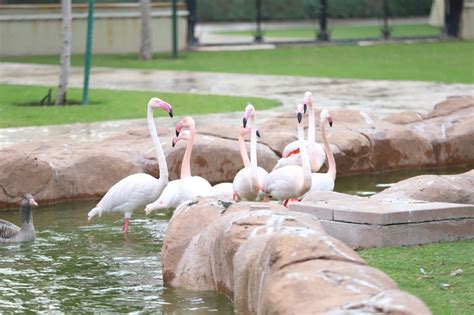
371 170 474 204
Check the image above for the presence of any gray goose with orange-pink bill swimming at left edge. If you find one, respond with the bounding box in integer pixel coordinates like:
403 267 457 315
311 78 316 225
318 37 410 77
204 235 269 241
0 195 38 243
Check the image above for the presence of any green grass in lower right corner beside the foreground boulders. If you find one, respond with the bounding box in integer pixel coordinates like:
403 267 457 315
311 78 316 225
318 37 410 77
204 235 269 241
358 240 474 315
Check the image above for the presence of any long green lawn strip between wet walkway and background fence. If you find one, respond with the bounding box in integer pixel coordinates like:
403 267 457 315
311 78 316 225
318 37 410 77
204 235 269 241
0 42 474 83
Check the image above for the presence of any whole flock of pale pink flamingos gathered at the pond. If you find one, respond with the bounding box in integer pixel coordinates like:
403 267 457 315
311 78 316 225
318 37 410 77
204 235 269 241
88 92 336 235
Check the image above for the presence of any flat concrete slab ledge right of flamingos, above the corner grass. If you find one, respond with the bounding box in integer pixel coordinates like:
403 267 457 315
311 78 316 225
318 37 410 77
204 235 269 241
289 192 474 248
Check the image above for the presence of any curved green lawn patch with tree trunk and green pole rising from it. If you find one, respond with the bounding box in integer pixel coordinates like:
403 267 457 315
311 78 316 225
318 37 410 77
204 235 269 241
0 84 279 128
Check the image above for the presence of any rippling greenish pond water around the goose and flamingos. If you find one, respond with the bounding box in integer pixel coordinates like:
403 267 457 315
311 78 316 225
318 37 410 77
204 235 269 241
0 168 469 314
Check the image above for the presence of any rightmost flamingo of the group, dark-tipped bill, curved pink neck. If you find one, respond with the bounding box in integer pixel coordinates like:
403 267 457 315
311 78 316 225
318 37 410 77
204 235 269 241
305 109 336 196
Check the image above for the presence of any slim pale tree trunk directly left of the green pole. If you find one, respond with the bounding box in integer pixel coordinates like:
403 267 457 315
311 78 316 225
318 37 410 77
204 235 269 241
56 0 72 105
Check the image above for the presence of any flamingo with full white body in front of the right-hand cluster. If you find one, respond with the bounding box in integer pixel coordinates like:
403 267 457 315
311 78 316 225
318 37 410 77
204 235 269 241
262 104 311 206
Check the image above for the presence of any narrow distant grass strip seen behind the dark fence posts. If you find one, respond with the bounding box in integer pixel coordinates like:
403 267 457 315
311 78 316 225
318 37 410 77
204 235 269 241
218 24 440 39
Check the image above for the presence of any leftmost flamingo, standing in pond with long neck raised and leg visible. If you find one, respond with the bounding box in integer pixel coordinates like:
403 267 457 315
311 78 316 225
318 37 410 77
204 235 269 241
88 97 173 235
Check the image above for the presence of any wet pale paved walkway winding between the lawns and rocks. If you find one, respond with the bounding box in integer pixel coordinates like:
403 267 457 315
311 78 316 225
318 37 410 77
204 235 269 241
0 63 474 147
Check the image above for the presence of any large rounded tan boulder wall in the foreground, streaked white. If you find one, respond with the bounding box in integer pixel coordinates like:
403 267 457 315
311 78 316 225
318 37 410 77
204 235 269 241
162 198 430 314
